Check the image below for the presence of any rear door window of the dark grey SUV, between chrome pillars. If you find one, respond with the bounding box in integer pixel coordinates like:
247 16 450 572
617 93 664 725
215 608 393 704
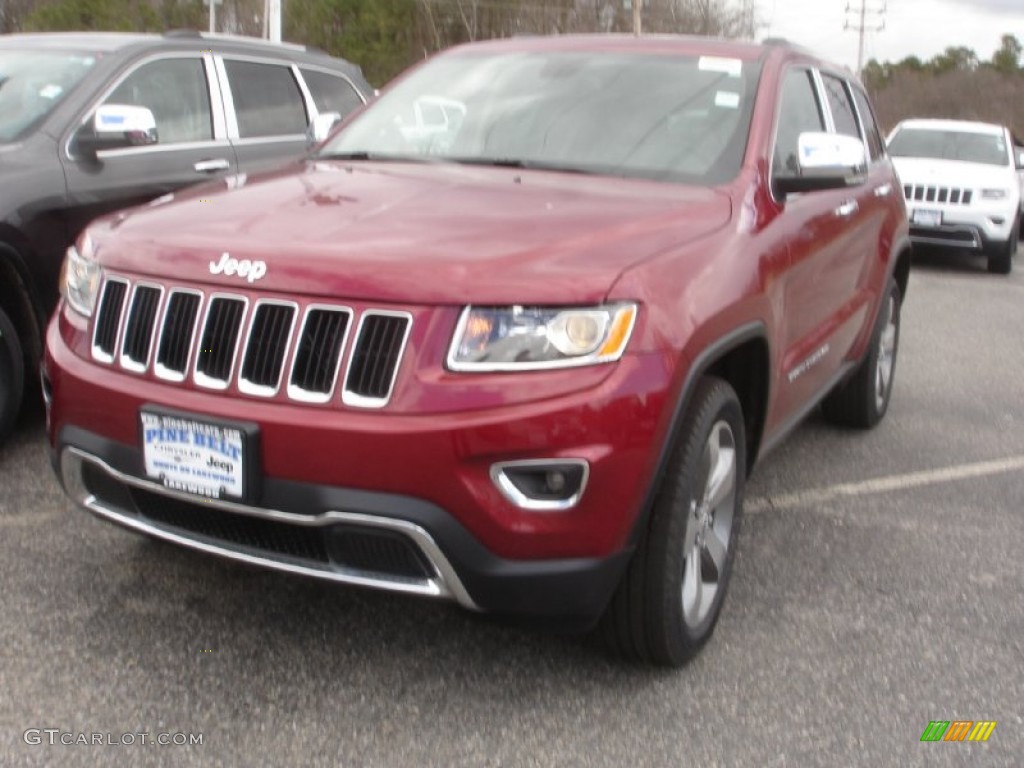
224 59 308 138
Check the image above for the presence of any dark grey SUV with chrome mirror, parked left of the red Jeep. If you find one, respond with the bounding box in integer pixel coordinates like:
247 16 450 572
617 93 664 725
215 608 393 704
0 32 374 440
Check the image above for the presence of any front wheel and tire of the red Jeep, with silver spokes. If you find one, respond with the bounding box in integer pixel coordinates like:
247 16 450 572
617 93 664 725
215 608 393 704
600 377 746 667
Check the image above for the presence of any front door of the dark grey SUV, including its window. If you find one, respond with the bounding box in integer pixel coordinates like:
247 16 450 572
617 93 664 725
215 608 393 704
60 51 237 232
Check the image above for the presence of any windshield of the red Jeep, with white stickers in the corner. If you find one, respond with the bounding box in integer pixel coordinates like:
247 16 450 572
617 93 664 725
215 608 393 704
321 51 759 184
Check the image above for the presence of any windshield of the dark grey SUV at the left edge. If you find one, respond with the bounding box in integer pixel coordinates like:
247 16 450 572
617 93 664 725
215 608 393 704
0 50 96 141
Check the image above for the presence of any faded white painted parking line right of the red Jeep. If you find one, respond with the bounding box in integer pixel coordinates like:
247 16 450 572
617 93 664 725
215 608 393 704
743 456 1024 514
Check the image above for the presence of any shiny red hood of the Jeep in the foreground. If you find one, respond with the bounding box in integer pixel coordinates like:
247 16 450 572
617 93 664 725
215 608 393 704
93 162 731 304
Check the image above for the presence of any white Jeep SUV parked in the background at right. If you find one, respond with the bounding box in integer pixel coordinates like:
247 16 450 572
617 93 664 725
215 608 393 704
889 120 1021 274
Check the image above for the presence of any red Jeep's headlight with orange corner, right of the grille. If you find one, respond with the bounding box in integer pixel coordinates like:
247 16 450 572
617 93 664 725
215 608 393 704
447 303 637 371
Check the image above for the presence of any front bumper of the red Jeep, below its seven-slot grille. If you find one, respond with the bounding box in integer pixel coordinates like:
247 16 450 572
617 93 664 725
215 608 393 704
44 311 669 629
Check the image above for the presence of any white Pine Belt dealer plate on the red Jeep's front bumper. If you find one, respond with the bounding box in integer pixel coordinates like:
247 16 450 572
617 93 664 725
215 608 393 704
139 411 246 499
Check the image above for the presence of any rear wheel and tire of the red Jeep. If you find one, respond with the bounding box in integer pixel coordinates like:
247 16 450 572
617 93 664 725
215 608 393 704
821 279 900 429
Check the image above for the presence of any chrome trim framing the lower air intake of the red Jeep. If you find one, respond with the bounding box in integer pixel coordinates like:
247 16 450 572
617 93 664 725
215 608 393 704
60 447 479 610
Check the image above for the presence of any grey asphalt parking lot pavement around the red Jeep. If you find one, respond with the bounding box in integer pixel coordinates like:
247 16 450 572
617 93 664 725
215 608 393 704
0 249 1024 767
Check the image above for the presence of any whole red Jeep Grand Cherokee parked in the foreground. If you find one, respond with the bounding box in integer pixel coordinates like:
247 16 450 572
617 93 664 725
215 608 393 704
44 37 909 665
